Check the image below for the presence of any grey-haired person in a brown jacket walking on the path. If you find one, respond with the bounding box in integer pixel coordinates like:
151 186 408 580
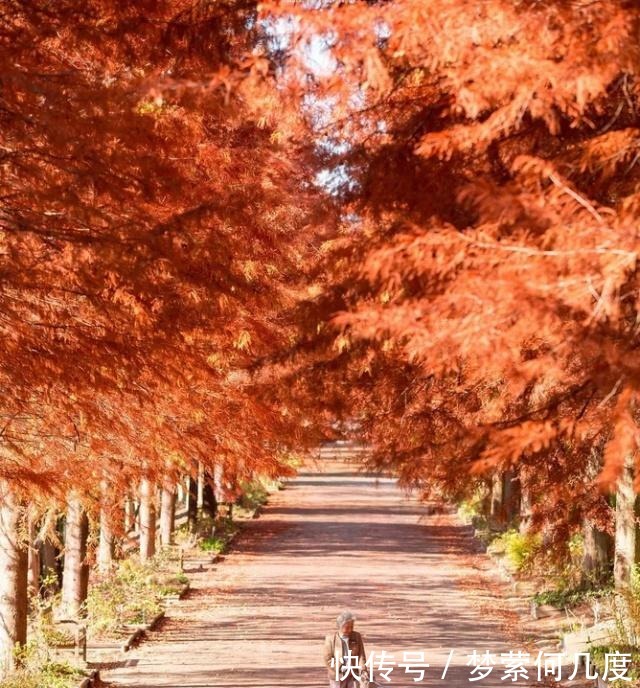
324 611 369 688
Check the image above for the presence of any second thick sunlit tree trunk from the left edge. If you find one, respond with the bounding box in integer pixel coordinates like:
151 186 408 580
62 493 89 618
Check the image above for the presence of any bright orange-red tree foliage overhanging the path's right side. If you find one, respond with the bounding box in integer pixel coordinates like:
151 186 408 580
264 0 640 536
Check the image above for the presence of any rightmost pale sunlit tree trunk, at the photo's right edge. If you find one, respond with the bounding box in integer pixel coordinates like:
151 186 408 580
613 455 636 589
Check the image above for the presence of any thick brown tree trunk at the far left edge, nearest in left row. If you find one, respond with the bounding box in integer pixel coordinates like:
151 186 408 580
0 480 28 675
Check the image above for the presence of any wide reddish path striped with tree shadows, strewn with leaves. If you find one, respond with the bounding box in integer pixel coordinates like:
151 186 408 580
103 462 535 688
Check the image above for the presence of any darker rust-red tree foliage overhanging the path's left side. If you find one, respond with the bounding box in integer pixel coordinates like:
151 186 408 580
0 0 320 500
